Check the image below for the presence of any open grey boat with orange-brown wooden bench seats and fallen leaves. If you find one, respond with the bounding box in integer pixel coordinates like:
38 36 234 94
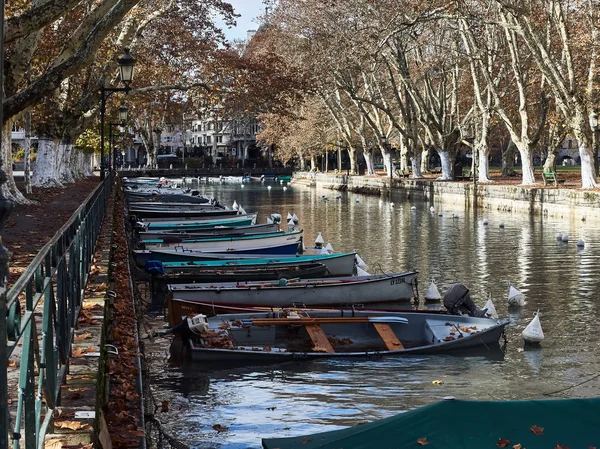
178 310 508 362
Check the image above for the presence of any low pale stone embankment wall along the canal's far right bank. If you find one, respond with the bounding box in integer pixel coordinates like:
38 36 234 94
293 173 600 221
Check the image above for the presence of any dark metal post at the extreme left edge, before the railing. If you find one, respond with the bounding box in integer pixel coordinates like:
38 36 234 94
0 163 13 449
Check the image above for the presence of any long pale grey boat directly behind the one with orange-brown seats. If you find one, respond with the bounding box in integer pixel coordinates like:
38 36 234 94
164 271 417 314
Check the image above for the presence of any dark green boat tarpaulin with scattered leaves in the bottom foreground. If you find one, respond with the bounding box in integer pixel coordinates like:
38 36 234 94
262 398 600 449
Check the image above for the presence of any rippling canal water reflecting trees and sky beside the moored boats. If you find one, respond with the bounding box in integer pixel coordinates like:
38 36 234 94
146 183 600 449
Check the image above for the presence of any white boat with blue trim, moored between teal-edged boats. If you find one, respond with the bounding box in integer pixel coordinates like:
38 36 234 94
140 231 302 250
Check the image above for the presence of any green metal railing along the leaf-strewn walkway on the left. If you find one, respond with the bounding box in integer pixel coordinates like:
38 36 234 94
0 172 114 449
